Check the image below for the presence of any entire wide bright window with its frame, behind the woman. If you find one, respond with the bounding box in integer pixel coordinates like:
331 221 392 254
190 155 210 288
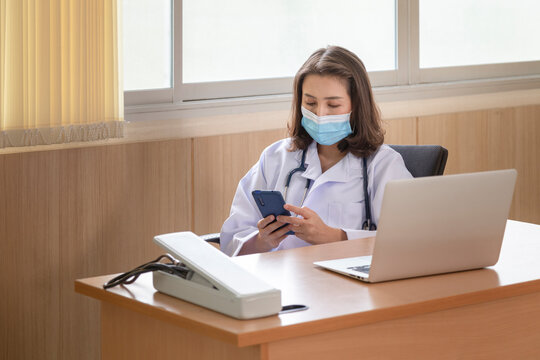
124 0 540 108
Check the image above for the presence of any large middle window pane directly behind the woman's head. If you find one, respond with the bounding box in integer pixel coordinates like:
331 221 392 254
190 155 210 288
180 0 396 100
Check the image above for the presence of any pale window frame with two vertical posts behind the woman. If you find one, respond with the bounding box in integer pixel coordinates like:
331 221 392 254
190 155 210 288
124 0 540 114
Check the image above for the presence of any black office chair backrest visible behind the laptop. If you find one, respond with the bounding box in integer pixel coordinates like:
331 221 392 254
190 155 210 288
390 145 448 177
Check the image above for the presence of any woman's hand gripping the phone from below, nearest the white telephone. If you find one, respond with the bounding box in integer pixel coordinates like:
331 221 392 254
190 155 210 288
238 215 290 255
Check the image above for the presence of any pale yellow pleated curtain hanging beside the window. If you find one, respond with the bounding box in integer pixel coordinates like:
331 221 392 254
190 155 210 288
0 0 124 148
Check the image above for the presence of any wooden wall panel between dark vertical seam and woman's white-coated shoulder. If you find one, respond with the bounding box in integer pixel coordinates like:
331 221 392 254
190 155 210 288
193 130 286 234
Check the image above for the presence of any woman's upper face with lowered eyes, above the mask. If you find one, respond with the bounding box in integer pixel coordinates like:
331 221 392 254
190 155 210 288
302 74 352 116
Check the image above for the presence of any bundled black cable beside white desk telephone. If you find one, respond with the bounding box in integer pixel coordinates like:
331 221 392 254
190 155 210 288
103 254 191 289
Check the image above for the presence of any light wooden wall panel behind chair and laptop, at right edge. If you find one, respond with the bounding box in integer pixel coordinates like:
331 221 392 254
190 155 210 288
418 106 540 224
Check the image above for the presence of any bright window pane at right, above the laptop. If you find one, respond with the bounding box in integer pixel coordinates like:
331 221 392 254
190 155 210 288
419 0 540 82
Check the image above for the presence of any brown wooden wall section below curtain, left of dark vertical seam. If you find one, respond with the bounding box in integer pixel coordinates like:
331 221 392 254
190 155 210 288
0 139 191 359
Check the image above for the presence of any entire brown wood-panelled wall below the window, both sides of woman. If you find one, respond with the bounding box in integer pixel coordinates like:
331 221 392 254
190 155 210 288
0 105 540 359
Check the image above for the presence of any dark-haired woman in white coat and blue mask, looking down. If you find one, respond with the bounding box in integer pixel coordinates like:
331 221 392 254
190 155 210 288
220 46 411 256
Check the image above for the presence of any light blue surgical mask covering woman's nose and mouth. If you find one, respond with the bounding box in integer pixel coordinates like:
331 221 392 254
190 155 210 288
301 106 352 145
